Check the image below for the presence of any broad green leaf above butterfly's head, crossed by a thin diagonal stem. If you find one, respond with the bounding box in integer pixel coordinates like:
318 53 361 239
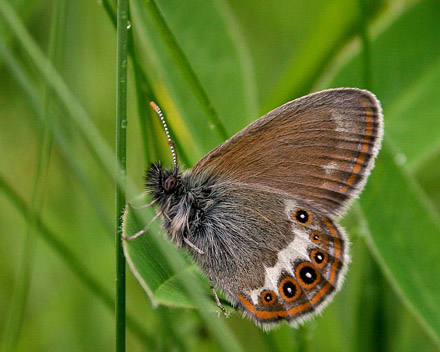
132 0 257 153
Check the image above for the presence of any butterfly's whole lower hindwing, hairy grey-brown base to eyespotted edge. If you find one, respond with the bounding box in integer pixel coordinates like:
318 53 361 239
182 182 348 327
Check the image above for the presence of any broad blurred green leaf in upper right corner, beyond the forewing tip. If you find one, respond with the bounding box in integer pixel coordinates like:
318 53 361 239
319 0 440 168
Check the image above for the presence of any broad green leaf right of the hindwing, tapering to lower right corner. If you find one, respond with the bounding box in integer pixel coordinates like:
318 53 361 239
361 140 440 344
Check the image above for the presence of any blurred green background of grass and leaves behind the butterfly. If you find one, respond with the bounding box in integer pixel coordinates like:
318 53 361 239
0 0 440 352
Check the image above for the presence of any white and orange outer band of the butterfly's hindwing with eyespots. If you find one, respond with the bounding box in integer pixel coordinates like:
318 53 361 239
232 200 349 326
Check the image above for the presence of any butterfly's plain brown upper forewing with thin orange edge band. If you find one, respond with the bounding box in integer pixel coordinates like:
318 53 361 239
193 88 383 214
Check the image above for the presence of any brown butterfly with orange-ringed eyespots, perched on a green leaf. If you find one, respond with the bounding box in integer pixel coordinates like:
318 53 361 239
133 88 383 327
